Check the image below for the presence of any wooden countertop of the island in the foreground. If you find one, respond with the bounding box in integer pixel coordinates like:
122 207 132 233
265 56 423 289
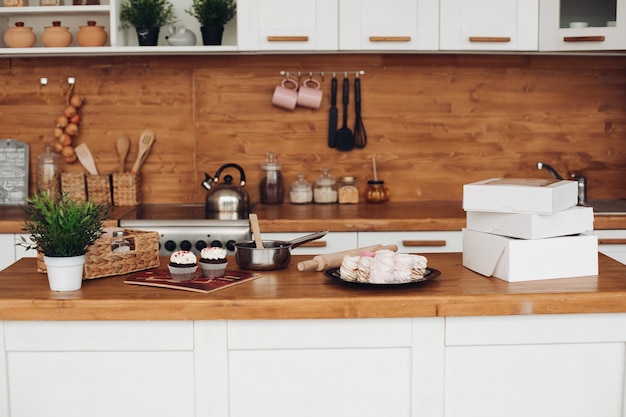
0 253 626 320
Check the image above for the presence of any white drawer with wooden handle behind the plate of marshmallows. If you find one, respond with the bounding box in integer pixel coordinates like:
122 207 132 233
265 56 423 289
359 230 463 253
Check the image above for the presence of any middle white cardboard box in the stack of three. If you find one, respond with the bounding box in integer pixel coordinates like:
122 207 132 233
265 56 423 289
466 206 593 239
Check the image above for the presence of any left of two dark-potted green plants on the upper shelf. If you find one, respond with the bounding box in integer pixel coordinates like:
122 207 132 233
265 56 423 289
120 0 176 46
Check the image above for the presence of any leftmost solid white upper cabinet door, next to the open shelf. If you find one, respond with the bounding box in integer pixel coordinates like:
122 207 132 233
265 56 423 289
237 0 338 51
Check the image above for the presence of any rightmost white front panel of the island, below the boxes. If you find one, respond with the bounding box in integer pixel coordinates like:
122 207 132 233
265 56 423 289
445 314 626 417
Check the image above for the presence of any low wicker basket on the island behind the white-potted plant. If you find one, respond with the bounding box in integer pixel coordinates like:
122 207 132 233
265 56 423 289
37 229 160 279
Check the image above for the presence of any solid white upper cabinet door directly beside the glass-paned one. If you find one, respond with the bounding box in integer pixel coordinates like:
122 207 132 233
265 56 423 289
439 0 539 51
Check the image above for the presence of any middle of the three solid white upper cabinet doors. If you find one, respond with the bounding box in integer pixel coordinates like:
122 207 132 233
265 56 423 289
339 0 439 51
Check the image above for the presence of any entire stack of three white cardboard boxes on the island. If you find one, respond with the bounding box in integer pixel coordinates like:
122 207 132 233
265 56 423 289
463 178 598 282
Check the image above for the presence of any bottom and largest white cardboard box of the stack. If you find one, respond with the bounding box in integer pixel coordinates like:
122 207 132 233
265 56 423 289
463 229 598 282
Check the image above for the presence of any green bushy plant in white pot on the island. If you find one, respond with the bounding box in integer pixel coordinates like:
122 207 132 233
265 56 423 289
19 192 108 291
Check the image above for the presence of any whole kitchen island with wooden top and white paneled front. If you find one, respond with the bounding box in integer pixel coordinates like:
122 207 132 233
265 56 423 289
0 253 626 417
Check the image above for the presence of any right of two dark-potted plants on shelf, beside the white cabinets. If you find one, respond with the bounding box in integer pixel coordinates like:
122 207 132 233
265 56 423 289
185 0 237 45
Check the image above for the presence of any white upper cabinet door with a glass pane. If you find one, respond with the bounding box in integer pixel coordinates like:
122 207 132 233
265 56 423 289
539 0 626 51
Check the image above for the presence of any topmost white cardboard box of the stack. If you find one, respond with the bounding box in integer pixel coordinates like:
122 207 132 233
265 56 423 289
463 178 578 214
